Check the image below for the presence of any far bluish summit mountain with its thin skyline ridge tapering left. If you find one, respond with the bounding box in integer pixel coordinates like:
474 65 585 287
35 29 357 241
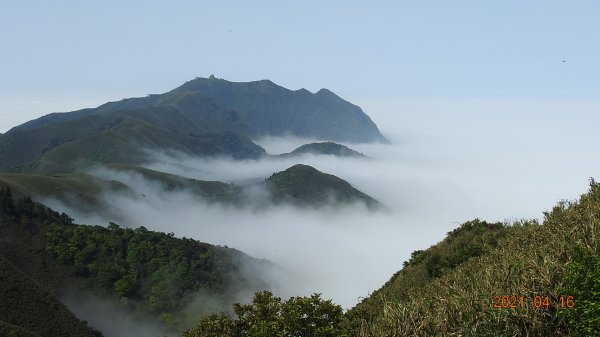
11 76 387 142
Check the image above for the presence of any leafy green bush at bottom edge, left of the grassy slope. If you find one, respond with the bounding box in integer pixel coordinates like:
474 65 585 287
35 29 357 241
182 291 343 337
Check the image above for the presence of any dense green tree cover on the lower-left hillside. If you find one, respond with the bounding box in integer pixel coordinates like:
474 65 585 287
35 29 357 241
46 223 266 327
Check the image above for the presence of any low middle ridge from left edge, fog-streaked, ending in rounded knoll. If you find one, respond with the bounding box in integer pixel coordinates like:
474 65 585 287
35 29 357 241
0 164 377 214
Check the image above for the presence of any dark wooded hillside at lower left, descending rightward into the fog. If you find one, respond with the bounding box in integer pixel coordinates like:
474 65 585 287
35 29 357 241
0 189 271 328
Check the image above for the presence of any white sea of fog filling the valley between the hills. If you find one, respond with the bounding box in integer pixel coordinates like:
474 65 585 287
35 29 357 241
43 97 600 308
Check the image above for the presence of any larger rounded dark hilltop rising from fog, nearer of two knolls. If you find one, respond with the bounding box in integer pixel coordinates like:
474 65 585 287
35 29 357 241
265 164 379 208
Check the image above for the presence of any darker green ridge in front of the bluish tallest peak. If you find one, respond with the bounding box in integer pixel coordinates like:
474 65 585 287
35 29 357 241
0 107 266 174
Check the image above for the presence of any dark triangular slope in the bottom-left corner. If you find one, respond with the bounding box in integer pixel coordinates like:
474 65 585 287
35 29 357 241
0 256 102 337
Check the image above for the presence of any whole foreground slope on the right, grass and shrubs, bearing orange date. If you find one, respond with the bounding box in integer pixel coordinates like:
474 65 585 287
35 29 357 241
347 182 600 336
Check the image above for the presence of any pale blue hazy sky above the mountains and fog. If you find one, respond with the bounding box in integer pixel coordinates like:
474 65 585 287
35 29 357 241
0 0 600 132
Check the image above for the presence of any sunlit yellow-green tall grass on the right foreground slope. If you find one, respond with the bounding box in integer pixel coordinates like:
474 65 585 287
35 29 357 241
354 180 600 337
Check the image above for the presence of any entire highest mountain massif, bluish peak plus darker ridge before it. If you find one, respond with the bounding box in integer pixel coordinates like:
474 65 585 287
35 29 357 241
0 77 386 174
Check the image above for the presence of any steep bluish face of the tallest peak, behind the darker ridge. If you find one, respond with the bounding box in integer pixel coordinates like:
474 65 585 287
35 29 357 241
170 77 387 142
